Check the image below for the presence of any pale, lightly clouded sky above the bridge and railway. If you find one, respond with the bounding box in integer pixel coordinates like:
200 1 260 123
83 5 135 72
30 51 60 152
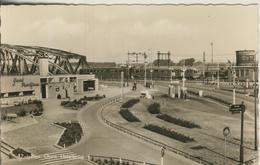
1 5 259 62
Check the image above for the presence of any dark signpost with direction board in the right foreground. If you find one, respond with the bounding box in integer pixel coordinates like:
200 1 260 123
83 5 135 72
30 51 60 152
229 101 246 164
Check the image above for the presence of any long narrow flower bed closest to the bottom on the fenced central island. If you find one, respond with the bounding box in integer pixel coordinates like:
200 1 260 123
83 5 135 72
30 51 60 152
143 124 195 143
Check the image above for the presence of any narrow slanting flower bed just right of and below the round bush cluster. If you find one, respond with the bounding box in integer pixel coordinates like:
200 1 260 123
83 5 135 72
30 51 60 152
156 114 201 128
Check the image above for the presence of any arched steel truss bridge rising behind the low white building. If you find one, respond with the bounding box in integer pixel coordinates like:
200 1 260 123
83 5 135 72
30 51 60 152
0 44 89 75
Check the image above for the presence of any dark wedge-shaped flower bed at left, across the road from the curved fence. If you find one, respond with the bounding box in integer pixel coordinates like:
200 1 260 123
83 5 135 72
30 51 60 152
55 122 83 147
